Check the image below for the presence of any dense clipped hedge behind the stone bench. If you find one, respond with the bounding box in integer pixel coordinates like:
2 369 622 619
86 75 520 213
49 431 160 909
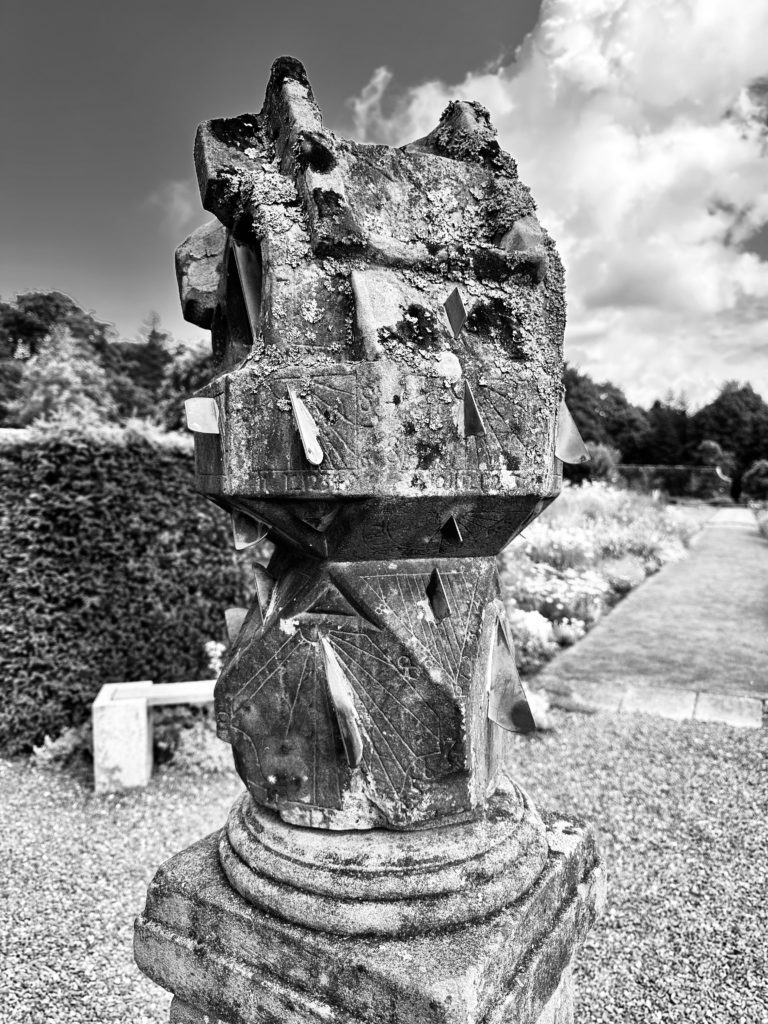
0 428 246 754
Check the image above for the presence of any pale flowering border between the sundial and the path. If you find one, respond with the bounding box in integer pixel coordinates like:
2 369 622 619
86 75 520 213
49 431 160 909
501 482 698 675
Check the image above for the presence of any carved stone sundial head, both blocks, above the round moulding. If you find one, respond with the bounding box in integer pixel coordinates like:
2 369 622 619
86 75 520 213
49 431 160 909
177 57 581 827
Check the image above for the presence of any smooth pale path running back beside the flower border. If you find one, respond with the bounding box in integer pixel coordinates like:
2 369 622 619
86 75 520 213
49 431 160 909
535 508 768 726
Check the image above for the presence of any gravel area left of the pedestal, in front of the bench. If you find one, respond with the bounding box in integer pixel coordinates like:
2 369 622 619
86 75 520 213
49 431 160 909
0 761 242 1024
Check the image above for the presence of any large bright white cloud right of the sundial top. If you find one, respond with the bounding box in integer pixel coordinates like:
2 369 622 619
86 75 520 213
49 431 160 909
350 0 768 402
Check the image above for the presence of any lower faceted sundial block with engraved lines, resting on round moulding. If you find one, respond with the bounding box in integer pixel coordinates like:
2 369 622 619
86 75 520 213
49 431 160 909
216 558 518 828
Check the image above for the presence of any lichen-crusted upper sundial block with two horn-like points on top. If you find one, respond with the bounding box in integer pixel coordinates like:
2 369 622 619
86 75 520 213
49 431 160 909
178 58 564 536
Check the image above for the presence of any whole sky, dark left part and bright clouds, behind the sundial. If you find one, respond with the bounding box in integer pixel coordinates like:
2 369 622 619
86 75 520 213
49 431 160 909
0 0 768 407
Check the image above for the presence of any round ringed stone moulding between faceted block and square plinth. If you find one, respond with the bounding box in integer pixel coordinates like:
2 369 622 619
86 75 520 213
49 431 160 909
219 785 548 935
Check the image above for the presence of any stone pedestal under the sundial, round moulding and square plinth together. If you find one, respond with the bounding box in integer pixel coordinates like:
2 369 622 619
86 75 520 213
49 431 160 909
135 793 604 1024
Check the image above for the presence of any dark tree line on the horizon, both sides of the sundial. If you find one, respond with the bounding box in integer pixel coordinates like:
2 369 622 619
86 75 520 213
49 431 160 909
0 292 768 492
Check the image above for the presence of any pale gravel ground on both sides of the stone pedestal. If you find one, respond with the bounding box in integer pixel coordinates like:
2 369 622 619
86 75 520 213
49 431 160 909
0 714 768 1024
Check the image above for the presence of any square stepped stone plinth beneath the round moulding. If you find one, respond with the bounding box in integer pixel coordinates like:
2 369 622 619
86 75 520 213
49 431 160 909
135 816 605 1024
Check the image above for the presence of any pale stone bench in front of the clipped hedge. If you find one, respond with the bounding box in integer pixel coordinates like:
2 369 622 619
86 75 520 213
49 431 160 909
91 679 216 793
